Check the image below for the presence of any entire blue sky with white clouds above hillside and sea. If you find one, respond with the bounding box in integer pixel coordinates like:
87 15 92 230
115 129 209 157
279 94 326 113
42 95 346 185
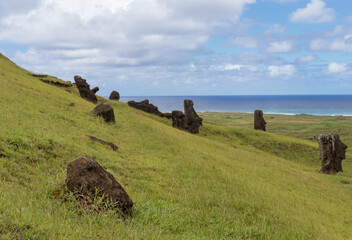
0 0 352 96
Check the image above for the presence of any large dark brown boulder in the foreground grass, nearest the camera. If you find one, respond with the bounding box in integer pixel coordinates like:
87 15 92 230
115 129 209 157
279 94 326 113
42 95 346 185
66 158 133 214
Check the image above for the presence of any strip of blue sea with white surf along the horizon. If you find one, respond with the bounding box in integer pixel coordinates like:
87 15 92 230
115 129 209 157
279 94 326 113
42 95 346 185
120 95 352 116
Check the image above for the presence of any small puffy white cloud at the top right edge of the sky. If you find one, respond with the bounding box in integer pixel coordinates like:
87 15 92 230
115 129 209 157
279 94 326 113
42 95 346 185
290 0 335 23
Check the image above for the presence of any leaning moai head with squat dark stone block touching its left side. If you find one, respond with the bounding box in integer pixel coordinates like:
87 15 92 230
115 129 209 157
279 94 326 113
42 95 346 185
172 99 203 133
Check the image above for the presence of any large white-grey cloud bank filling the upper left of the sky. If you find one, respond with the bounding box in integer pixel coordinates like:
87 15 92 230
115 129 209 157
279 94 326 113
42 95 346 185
0 0 255 67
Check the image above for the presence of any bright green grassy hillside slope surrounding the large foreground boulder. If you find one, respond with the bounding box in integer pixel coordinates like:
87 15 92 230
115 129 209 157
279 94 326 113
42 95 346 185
0 53 352 239
